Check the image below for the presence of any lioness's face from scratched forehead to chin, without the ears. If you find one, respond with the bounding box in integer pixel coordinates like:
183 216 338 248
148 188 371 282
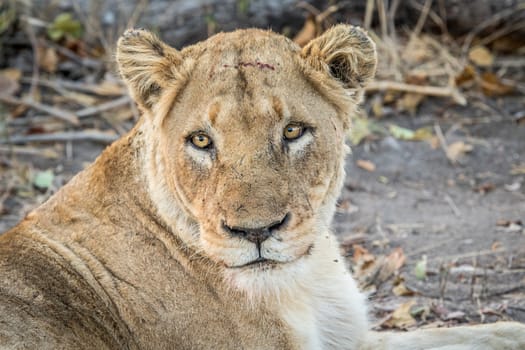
165 55 344 269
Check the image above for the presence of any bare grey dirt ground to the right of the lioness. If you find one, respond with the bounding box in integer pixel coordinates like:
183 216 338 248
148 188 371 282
335 98 525 324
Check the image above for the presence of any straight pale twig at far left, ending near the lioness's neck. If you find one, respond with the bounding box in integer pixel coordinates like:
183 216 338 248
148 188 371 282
0 131 118 144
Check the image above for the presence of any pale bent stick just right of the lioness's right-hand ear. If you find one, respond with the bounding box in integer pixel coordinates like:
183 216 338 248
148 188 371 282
365 81 467 106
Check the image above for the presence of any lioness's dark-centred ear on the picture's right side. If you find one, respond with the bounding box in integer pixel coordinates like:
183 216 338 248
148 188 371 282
301 24 377 89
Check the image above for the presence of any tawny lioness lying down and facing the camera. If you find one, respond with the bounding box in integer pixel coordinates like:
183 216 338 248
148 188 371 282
0 25 525 350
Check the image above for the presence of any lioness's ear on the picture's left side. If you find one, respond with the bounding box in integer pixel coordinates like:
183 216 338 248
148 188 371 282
117 29 182 110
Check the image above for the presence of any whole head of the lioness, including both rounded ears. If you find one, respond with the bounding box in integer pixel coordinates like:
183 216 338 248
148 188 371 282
118 26 376 292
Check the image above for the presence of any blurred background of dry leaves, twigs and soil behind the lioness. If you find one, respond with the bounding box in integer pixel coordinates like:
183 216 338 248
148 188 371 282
0 0 525 329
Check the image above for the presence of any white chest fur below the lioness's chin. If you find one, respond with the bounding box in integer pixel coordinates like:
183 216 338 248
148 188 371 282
276 235 368 350
